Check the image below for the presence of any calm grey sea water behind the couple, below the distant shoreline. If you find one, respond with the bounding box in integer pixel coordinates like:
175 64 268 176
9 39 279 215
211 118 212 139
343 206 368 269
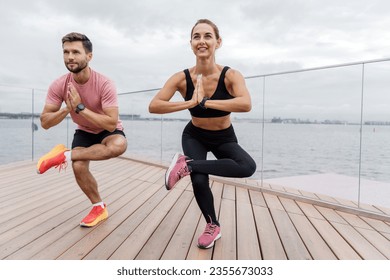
0 119 390 182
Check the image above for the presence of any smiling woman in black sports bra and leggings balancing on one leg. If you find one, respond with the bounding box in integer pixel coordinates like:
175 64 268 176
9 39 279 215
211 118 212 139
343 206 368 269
149 19 256 248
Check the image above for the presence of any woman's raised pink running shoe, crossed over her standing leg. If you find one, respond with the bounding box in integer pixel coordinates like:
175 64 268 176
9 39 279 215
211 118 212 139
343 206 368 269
165 153 191 191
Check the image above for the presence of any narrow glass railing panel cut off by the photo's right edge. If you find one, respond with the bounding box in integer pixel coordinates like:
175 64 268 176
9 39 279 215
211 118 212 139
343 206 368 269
360 62 390 207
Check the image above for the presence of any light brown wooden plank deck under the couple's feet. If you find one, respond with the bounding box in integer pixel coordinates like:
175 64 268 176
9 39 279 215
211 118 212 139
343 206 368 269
0 158 390 260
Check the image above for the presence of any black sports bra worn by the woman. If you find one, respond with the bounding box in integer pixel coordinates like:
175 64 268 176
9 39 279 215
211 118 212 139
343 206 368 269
184 66 234 118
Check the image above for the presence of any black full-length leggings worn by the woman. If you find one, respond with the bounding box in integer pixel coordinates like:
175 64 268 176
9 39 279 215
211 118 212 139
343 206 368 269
182 122 256 225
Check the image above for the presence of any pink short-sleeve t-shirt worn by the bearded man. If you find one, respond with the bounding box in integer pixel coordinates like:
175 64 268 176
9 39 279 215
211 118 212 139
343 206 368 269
46 69 123 134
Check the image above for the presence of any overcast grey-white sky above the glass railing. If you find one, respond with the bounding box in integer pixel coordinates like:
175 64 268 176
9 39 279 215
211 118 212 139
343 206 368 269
0 0 390 120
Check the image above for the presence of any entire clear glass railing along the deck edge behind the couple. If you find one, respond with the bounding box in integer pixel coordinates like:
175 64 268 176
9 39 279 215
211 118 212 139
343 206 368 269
0 58 390 207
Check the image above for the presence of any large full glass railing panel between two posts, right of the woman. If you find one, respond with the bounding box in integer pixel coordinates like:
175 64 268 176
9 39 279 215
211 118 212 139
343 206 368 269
263 66 362 201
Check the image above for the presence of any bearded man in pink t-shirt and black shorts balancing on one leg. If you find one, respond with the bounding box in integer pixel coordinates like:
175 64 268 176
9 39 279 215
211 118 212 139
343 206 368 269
37 33 127 227
